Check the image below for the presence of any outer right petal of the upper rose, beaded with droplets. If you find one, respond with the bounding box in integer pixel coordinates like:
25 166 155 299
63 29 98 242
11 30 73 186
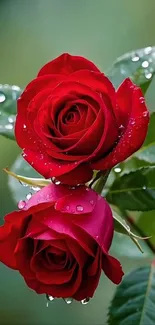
92 79 149 170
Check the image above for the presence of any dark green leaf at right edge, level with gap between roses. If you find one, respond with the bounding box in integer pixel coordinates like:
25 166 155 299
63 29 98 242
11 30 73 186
106 166 155 211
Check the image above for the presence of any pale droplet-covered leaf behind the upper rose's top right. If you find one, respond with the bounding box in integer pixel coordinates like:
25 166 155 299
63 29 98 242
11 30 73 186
107 46 155 94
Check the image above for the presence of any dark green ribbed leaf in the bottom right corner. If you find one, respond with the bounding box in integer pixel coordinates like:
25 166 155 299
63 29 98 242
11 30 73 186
108 263 155 325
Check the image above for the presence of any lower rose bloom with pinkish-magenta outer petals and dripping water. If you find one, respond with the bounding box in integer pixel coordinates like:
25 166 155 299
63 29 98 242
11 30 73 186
0 184 123 300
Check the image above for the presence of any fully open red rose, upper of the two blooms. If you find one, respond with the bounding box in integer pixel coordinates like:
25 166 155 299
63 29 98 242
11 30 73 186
15 54 149 184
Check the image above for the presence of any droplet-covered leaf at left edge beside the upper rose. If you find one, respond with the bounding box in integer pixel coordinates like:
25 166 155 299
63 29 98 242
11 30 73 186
0 85 22 139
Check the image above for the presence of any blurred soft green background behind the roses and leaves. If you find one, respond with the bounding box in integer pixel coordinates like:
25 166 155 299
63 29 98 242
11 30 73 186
0 0 155 325
